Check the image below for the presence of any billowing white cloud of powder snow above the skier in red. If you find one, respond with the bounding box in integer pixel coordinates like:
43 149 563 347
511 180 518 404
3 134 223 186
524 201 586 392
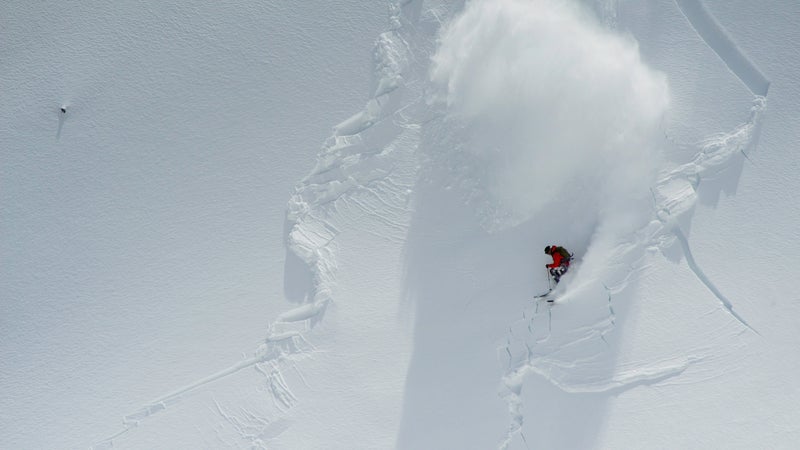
431 0 668 243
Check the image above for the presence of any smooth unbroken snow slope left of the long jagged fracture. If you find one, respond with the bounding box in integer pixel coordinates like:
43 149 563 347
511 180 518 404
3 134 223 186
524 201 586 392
0 1 386 448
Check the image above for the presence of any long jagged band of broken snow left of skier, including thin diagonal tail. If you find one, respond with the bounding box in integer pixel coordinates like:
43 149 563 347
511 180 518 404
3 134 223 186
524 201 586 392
92 1 419 449
